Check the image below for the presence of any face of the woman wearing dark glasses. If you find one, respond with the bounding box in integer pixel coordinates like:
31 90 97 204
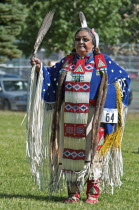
75 30 94 57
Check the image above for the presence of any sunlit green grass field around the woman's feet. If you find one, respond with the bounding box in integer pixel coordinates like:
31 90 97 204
0 111 139 210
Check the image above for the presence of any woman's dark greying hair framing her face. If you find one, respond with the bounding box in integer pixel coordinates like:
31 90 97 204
72 27 100 55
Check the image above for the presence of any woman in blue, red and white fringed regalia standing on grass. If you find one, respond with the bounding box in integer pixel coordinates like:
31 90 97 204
27 11 130 203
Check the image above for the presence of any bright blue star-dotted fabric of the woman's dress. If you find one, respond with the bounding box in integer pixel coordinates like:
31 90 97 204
42 55 130 133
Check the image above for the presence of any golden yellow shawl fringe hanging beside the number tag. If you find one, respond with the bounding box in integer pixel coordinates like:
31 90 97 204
99 82 123 155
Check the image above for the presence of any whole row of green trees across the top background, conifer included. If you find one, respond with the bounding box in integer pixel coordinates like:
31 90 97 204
0 0 139 62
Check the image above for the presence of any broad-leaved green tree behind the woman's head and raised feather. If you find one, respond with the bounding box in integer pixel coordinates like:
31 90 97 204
20 0 139 55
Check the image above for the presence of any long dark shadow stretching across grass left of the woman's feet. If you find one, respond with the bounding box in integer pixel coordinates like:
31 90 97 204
0 194 65 203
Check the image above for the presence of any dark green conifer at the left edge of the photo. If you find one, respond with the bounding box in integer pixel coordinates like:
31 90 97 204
0 0 25 62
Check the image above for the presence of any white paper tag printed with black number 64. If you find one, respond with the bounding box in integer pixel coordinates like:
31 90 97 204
101 108 118 123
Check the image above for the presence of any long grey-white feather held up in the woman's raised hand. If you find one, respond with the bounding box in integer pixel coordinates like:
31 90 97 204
33 11 54 56
